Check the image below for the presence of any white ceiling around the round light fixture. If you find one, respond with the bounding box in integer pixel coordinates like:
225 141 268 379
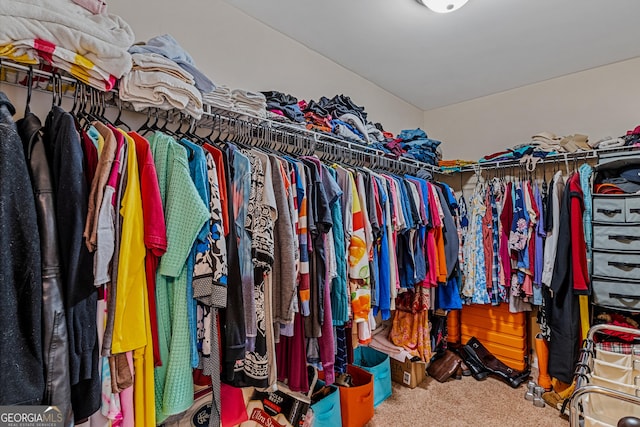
226 0 640 110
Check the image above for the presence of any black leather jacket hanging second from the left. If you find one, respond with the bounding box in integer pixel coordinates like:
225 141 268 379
17 108 73 425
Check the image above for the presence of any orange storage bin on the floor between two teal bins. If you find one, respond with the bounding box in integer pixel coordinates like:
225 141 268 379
338 365 373 427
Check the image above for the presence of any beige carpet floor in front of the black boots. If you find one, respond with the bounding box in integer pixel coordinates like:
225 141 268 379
366 377 569 427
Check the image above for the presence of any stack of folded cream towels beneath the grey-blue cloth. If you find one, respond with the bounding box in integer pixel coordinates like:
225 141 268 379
119 53 203 119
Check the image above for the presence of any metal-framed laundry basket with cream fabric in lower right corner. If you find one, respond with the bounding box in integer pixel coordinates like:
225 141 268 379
570 325 640 427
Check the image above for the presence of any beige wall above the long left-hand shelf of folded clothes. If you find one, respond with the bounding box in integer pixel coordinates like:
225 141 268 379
108 0 423 133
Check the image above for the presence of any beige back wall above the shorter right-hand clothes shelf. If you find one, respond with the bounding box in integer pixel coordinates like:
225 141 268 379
423 58 640 160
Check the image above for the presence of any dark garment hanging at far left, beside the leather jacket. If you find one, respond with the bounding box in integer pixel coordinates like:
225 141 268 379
0 92 45 405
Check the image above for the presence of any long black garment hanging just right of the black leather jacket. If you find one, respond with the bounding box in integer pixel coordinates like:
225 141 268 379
44 106 101 420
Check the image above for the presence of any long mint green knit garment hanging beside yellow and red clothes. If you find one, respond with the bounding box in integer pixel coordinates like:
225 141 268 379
149 132 211 424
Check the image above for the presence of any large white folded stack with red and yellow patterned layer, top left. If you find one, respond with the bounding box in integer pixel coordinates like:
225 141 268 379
0 0 135 90
